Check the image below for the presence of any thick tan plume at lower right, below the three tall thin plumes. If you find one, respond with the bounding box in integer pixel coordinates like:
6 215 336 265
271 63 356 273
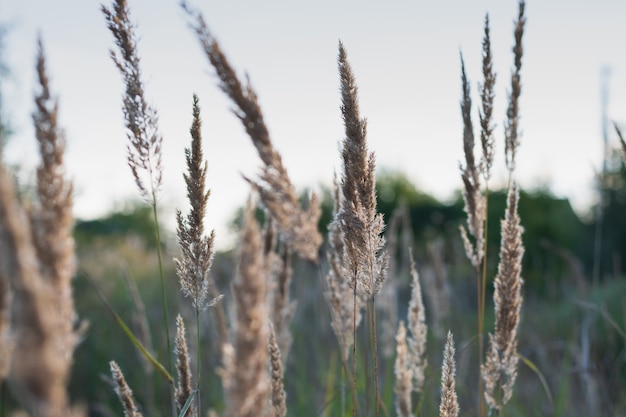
481 183 524 410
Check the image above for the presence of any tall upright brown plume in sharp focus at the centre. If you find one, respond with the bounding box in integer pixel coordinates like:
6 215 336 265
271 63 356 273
334 42 389 298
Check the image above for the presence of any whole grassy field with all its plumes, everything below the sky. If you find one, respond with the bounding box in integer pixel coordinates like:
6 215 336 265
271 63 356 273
0 0 626 417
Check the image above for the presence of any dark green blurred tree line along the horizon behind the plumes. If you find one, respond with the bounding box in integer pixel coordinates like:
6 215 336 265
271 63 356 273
75 153 626 295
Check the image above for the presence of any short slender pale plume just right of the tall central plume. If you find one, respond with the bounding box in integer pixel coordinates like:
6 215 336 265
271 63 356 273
407 254 428 393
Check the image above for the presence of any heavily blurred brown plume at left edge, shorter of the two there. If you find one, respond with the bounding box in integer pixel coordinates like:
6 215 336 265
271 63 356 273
0 166 68 417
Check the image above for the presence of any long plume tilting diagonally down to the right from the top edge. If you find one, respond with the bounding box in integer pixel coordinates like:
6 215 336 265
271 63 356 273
182 1 316 261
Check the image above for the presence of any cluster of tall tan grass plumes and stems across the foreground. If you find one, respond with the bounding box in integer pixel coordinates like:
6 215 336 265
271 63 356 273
0 0 626 417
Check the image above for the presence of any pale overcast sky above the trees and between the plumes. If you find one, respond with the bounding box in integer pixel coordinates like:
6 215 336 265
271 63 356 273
0 0 626 245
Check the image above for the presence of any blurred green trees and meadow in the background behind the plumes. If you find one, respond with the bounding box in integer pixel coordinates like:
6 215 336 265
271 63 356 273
37 154 626 416
